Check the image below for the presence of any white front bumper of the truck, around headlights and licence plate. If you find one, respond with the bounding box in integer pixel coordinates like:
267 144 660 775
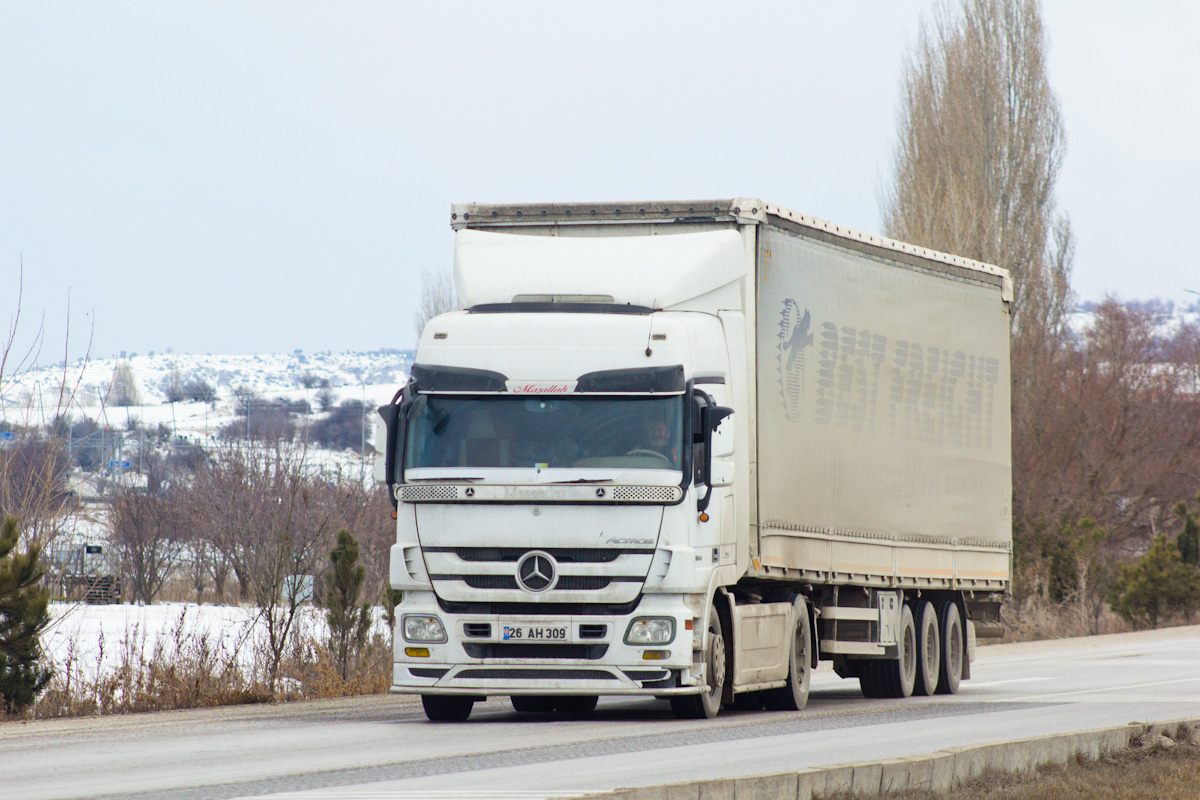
391 593 703 697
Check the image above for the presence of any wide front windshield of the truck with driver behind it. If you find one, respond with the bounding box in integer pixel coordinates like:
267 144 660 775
404 395 683 470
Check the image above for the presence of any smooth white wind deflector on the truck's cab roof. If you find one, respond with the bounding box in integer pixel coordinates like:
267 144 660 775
454 230 746 309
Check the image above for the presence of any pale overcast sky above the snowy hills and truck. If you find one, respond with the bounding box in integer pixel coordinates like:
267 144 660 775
0 0 1200 359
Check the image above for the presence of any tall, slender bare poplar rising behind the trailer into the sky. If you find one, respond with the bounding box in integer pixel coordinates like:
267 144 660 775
883 0 1073 340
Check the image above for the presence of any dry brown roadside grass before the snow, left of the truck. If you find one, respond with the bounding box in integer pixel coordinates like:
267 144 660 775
0 612 391 720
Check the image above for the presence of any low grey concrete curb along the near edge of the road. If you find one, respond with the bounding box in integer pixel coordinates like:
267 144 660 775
566 718 1200 800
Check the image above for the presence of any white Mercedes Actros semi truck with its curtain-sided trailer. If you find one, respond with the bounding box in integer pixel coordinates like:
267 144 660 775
377 198 1013 720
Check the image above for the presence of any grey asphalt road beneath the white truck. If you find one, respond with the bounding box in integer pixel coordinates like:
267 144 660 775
9 626 1200 800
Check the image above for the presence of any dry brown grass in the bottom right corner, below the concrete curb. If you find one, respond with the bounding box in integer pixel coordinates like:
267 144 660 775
823 732 1200 800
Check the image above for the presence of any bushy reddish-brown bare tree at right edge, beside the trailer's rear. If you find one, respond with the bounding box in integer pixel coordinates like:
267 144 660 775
1013 299 1200 632
